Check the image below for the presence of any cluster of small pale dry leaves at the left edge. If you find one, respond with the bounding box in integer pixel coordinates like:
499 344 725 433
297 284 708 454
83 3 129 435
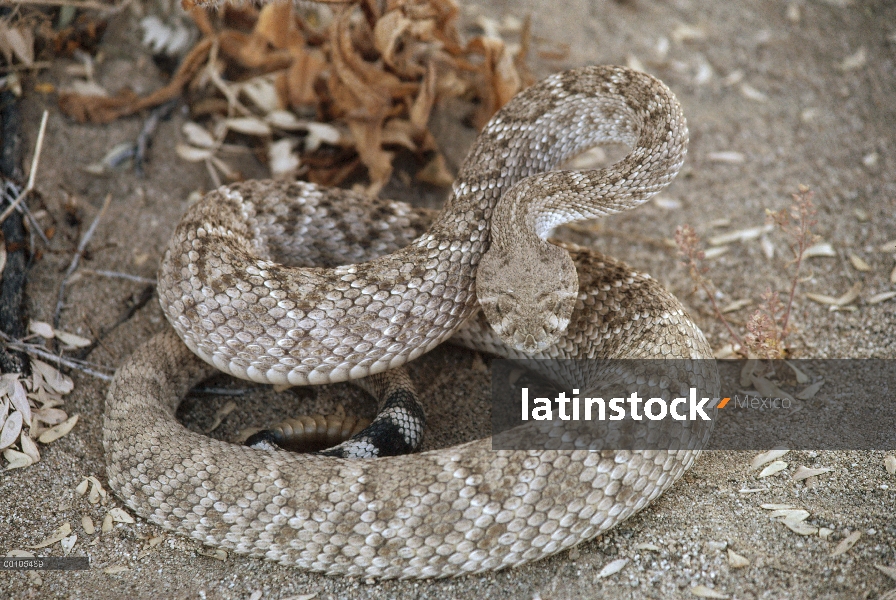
0 323 83 470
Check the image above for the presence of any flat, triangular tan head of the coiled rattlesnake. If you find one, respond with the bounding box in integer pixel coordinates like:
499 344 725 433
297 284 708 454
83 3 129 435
476 240 579 354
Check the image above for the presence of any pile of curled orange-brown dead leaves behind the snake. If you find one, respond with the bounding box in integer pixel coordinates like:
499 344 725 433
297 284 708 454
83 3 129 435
60 0 531 194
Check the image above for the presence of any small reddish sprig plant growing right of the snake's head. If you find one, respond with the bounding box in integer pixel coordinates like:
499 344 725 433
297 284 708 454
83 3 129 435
675 185 818 359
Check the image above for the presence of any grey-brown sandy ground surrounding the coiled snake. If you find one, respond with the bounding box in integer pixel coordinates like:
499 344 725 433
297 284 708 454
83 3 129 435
0 0 896 599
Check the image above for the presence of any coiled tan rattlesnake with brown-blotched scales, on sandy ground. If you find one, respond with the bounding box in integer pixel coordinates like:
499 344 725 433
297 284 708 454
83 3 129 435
104 67 711 578
